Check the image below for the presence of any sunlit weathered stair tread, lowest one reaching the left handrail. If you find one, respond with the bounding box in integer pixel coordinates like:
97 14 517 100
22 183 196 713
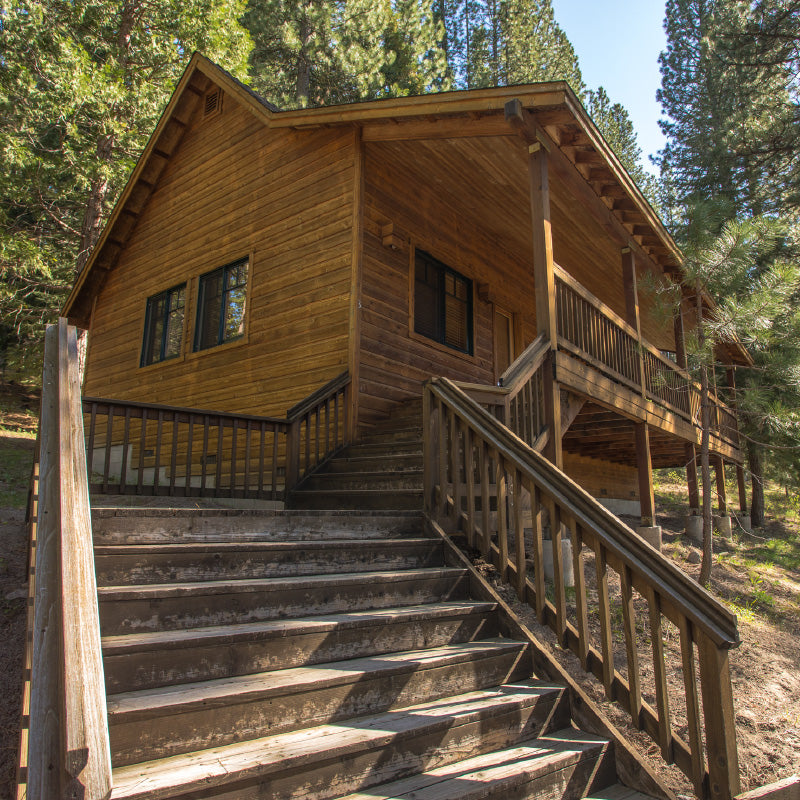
111 681 562 800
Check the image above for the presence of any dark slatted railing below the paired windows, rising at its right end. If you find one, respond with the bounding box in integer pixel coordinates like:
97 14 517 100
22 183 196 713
83 372 350 500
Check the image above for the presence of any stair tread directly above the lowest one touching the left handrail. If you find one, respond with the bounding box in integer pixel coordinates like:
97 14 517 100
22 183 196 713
108 639 524 721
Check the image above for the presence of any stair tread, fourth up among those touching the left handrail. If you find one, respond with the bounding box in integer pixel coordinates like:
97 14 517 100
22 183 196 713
97 567 467 601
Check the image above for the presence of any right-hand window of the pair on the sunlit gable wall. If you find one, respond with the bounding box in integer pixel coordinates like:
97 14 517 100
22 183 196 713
194 258 248 350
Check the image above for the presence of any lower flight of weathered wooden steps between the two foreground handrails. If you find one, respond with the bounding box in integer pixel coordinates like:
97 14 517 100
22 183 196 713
93 500 648 800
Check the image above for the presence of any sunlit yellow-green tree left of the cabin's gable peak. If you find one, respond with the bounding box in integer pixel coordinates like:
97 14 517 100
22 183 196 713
0 0 250 372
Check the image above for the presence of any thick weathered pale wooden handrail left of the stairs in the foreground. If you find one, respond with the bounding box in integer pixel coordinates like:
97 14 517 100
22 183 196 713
24 318 112 800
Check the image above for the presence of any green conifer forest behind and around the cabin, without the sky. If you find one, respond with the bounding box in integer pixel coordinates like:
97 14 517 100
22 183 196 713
0 0 800 524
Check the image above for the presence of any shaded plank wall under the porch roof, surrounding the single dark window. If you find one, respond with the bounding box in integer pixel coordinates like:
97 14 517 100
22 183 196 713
359 142 536 434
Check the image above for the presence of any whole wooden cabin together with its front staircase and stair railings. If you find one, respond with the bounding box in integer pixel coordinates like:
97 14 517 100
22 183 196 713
19 55 777 800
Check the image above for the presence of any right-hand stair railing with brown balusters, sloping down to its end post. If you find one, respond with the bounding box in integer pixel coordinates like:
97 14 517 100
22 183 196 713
423 378 739 800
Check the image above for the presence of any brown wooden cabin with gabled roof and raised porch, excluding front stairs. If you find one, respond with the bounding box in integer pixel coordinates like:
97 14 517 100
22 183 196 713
64 56 746 525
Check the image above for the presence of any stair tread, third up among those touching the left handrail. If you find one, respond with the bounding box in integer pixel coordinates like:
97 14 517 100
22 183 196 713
101 601 497 655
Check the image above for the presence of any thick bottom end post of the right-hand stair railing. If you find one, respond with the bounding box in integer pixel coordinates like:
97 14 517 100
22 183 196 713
697 634 741 800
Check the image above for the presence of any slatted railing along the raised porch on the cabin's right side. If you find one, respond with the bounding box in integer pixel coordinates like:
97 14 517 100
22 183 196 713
555 267 739 447
